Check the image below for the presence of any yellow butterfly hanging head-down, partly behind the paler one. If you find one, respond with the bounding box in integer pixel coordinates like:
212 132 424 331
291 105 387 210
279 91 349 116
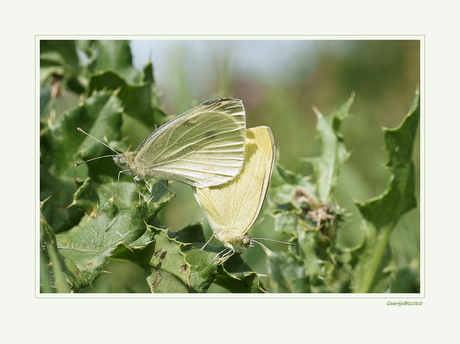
195 126 293 264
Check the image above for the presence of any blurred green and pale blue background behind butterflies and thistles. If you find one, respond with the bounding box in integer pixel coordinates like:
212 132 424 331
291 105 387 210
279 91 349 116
51 39 423 292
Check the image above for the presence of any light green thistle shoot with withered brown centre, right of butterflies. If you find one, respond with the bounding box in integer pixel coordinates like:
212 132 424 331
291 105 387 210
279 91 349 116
268 95 360 292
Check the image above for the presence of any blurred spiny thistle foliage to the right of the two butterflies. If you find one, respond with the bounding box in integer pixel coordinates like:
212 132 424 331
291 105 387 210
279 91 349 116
267 93 420 293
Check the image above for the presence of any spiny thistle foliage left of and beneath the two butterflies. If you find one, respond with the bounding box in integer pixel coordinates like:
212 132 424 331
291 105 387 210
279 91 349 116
40 41 264 293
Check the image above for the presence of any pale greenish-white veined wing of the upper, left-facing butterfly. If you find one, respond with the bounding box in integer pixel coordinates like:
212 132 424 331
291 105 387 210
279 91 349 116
135 98 246 188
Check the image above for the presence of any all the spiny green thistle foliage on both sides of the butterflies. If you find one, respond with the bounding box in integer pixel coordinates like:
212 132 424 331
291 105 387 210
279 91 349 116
39 41 419 293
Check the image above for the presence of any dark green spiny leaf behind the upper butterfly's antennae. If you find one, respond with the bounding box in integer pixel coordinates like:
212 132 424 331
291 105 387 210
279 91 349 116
40 92 125 233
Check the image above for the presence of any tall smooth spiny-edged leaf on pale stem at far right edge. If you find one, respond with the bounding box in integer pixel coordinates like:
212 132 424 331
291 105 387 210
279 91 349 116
353 92 420 292
